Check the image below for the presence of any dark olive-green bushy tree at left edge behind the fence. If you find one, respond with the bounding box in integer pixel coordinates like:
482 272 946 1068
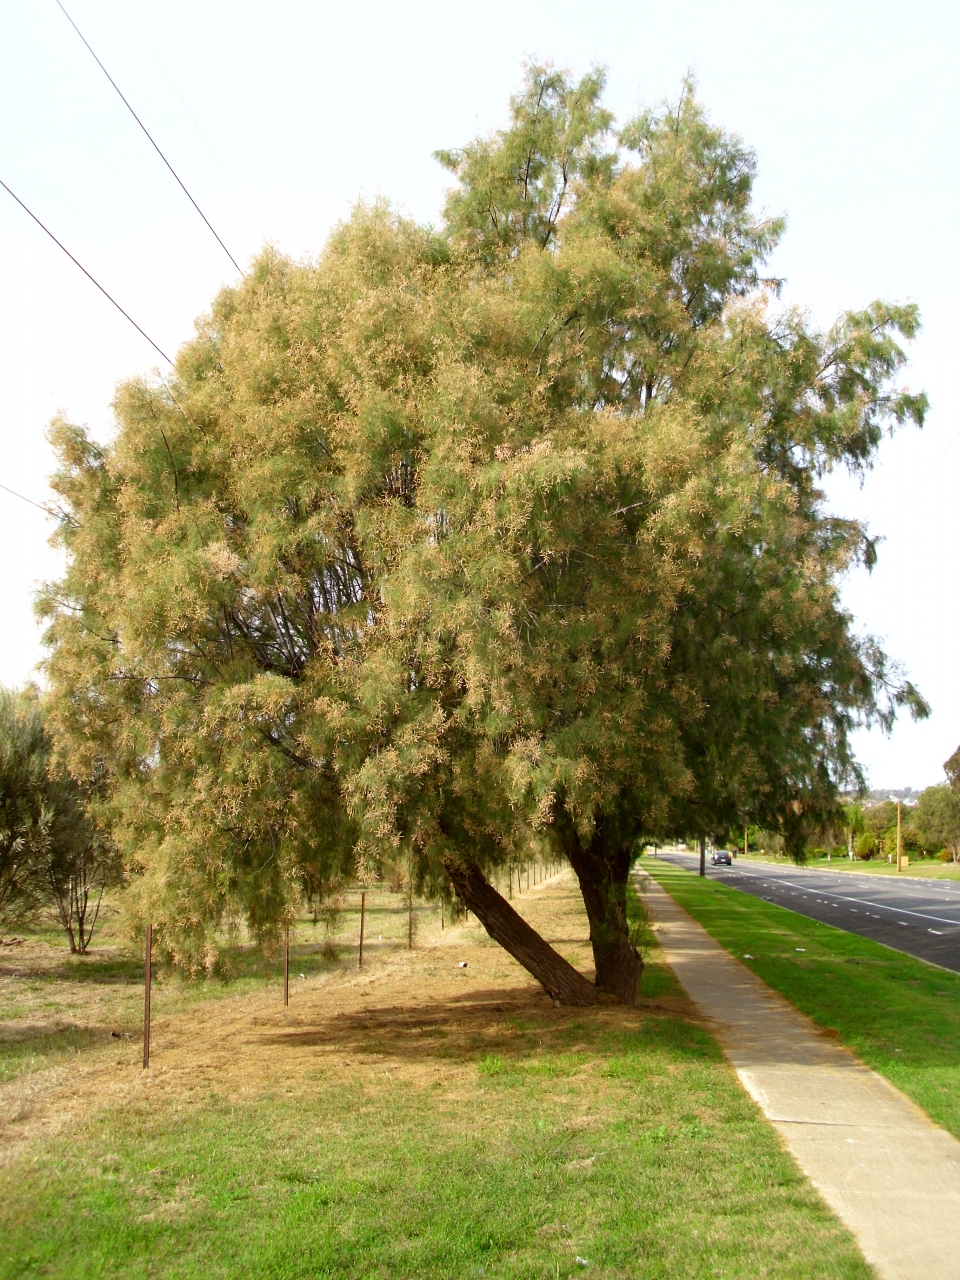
0 687 119 955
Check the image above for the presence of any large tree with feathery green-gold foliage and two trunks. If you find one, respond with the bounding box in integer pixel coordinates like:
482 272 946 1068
42 68 925 1002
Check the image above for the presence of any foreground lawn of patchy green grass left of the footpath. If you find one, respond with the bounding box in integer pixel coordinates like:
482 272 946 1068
0 921 872 1280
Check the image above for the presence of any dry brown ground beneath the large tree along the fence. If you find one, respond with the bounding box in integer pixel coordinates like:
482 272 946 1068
0 873 695 1162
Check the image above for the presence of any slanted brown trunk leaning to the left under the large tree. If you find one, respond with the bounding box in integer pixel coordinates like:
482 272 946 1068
444 860 596 1005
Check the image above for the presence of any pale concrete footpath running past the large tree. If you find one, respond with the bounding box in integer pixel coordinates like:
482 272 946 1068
644 882 960 1280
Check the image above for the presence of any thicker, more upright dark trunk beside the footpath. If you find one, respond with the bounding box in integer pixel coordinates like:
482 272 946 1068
553 810 644 1005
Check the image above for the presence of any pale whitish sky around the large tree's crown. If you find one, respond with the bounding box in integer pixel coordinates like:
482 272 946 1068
0 0 960 787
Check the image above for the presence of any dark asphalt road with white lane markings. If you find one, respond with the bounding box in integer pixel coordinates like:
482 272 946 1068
659 851 960 973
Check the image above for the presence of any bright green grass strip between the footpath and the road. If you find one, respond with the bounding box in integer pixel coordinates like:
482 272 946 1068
644 859 960 1138
